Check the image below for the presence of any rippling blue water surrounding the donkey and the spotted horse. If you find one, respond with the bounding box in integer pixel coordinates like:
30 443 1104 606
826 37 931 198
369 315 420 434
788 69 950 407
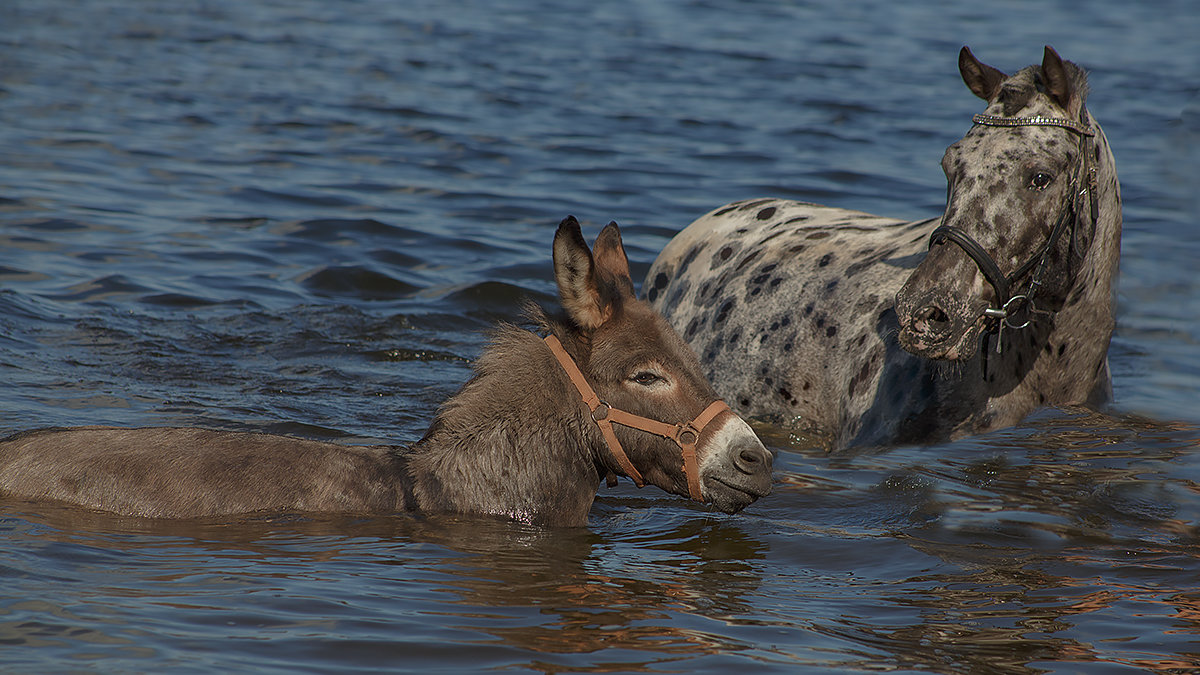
0 0 1200 674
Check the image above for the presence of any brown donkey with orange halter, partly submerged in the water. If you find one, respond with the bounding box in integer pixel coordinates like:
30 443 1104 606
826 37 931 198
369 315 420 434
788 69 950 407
0 217 772 526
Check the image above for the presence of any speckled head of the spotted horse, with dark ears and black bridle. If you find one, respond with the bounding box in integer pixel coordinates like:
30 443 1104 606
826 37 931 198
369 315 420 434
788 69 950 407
896 47 1096 360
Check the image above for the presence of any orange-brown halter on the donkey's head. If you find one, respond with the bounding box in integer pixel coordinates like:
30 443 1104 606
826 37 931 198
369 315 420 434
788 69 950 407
544 335 732 502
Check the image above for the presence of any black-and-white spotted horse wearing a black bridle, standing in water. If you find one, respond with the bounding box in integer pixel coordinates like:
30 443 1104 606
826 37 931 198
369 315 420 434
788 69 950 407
643 47 1121 447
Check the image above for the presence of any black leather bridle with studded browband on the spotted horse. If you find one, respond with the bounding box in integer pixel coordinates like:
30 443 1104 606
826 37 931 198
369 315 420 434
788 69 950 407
929 110 1099 345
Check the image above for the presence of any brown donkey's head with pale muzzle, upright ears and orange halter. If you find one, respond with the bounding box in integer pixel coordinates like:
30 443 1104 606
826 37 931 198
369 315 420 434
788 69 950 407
547 217 772 513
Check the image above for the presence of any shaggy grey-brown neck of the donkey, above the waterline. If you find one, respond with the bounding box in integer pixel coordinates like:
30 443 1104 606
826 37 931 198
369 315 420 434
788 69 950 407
408 325 609 525
